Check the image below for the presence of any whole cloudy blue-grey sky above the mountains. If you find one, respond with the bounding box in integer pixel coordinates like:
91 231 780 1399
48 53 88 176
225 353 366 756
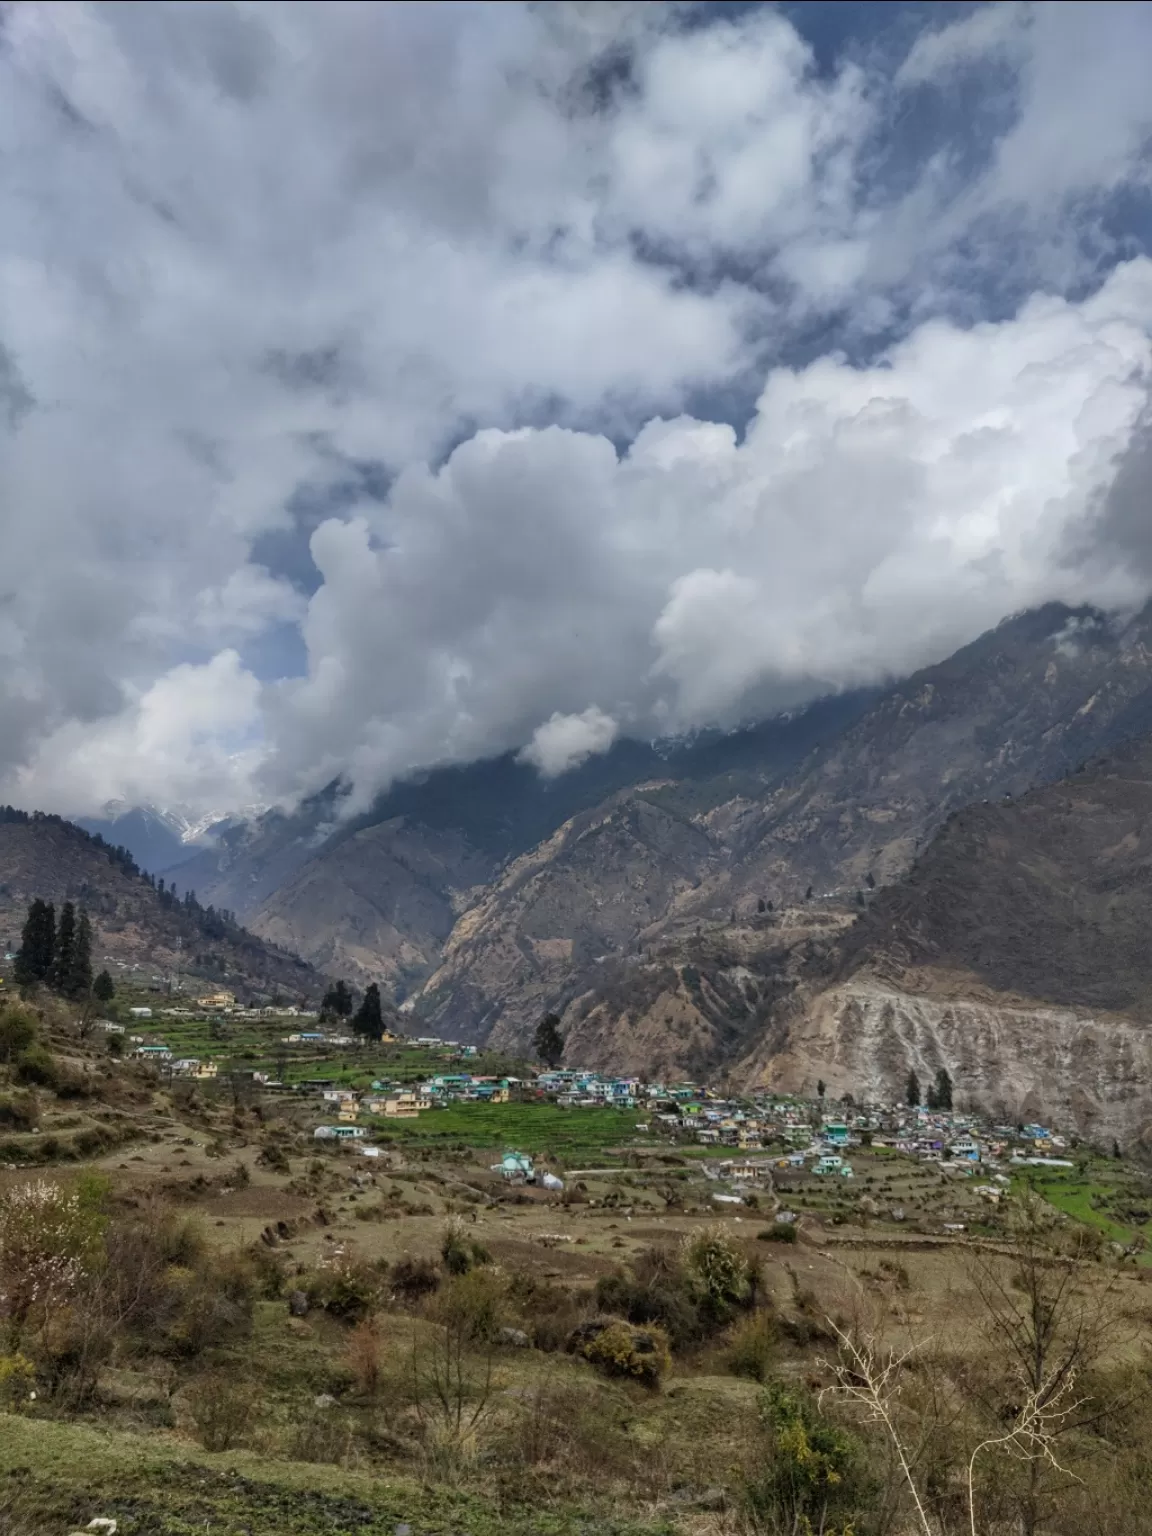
0 0 1152 814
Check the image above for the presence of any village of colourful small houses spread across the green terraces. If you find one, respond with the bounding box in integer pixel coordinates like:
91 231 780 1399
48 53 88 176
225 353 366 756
101 992 1074 1204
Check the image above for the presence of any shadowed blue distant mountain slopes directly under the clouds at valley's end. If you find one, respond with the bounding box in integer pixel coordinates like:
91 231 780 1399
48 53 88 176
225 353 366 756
172 690 877 989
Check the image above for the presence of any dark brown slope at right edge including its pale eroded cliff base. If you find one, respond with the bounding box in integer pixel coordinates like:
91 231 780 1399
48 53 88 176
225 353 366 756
743 737 1152 1141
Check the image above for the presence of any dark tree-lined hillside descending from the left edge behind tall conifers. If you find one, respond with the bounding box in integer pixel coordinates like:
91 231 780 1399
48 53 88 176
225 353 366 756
0 806 321 1000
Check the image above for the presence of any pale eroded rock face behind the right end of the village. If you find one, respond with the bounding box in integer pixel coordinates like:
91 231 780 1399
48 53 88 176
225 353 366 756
742 972 1152 1144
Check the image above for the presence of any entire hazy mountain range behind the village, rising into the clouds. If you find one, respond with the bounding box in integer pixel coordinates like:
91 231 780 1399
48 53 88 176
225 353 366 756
18 604 1152 1138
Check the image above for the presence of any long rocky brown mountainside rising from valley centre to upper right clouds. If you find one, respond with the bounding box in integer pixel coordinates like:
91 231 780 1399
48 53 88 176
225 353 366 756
418 605 1152 1046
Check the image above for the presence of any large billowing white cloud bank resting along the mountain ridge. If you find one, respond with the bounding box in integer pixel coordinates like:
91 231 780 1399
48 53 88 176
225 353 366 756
259 260 1152 805
